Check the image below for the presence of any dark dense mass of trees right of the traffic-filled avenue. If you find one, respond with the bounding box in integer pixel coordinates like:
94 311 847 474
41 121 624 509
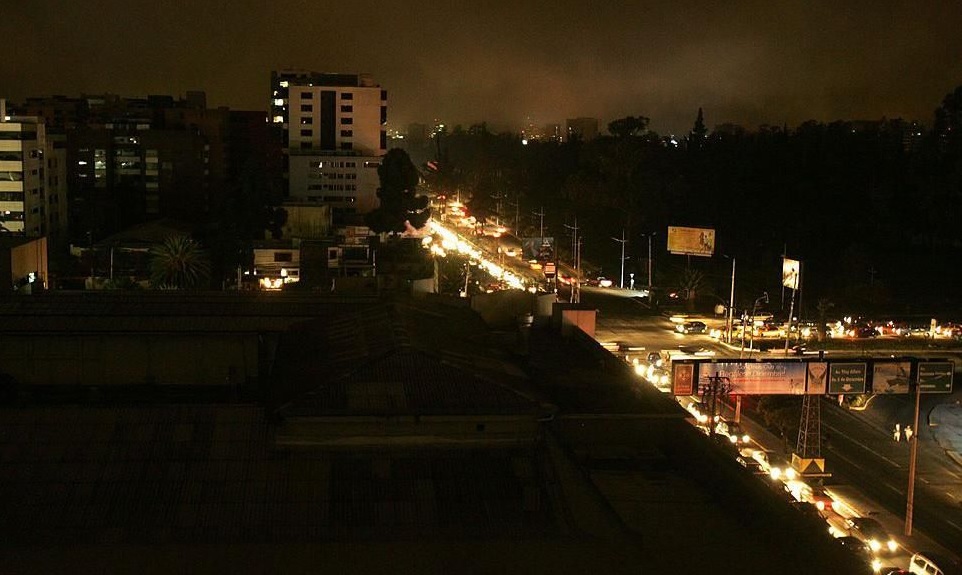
412 87 962 316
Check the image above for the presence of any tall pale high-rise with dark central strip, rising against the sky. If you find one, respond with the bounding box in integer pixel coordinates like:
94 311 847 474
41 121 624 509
270 70 387 223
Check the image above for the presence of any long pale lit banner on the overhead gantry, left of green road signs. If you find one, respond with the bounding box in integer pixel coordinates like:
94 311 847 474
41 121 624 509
698 361 808 395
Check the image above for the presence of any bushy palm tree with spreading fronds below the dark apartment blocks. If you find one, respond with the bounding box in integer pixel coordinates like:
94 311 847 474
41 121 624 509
150 236 210 289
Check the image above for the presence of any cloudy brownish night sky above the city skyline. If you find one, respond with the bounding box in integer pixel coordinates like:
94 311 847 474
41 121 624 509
7 0 962 134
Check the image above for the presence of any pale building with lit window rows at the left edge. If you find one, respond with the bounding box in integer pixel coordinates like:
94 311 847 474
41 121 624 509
0 100 67 240
